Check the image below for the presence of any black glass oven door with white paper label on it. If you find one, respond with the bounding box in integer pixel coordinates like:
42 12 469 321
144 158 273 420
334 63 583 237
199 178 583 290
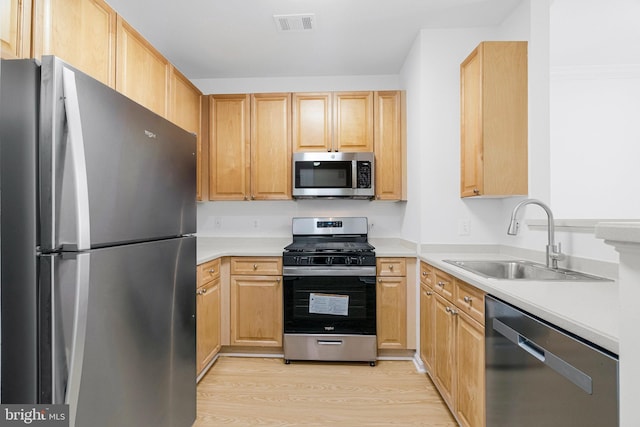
284 275 376 335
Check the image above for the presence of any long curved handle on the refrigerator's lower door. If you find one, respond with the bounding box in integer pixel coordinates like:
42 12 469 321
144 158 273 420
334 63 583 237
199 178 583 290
64 253 91 426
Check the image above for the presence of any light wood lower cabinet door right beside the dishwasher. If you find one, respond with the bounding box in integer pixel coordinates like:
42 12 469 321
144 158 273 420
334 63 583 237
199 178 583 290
456 313 485 427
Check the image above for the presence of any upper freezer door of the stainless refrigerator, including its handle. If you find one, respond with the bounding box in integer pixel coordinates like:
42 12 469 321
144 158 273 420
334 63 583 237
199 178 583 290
40 56 196 252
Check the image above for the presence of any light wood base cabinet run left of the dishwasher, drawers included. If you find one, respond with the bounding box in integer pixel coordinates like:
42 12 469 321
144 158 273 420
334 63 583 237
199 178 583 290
420 262 485 427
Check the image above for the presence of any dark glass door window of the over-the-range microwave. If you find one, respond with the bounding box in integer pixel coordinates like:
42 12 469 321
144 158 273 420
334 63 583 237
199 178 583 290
295 161 352 188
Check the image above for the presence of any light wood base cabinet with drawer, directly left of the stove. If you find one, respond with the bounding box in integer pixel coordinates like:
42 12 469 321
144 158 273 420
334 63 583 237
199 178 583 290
230 257 283 347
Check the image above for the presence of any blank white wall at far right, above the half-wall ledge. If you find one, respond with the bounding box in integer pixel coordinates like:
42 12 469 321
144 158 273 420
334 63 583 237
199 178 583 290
550 0 640 219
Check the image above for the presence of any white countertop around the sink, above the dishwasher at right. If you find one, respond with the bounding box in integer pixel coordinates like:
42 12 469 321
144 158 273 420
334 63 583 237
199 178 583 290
420 252 620 354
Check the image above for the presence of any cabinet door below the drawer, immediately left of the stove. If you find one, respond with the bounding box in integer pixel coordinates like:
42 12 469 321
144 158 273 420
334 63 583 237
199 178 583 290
231 276 282 347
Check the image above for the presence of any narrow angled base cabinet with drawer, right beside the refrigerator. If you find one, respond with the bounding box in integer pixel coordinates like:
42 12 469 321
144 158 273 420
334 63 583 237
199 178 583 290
196 259 221 375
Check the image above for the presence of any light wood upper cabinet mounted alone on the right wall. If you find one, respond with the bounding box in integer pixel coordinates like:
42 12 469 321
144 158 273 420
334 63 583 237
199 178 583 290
460 42 528 197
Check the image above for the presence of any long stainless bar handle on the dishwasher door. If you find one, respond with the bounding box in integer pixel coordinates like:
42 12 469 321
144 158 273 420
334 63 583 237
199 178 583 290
493 318 593 394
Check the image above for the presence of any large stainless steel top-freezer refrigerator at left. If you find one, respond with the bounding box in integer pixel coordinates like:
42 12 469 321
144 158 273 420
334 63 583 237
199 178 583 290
0 56 196 427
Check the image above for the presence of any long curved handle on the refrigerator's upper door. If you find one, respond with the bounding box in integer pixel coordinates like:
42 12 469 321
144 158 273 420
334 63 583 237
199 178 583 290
62 67 91 251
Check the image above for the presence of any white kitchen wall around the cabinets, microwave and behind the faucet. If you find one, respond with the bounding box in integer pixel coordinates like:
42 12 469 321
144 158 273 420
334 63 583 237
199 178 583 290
195 0 624 262
